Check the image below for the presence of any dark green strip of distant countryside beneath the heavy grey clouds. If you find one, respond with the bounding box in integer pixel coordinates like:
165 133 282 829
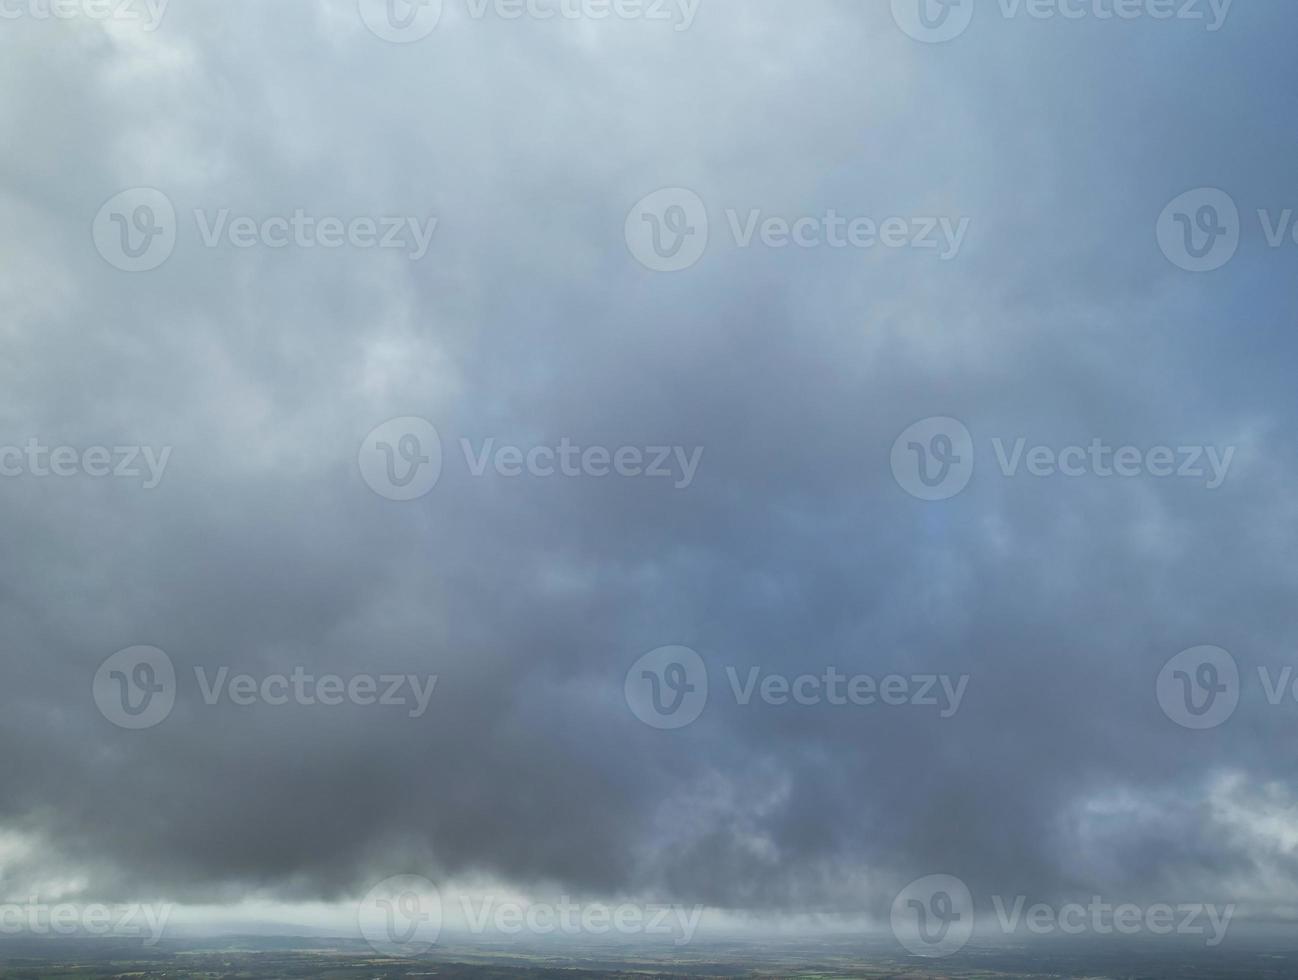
0 937 1298 980
